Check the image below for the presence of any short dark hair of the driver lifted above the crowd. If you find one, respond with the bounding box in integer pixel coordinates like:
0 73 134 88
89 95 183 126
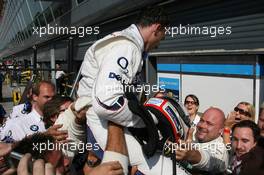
136 6 169 27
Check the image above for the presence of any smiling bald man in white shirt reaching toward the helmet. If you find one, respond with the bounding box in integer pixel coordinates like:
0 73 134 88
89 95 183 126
176 107 228 174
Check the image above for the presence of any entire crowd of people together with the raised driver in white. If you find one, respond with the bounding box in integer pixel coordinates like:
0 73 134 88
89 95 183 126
0 7 264 175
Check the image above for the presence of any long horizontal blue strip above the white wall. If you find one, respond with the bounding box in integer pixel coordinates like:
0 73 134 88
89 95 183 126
157 64 254 75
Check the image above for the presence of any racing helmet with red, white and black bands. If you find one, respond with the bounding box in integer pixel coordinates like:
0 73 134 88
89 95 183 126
144 96 190 144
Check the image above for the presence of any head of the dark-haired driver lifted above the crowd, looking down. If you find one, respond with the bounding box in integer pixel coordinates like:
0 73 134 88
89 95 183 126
136 7 169 51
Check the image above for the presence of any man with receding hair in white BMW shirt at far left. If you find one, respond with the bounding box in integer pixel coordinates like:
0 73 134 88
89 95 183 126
1 81 55 142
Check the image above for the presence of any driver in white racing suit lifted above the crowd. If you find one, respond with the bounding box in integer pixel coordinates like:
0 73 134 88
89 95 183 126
78 8 191 175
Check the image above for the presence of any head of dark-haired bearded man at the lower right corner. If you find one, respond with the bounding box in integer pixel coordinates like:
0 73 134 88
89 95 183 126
232 120 260 157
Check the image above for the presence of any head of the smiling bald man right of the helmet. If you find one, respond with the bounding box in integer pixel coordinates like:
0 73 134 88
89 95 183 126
195 107 225 143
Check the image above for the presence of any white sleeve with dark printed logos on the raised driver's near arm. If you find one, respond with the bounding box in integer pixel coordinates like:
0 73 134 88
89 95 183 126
93 41 144 127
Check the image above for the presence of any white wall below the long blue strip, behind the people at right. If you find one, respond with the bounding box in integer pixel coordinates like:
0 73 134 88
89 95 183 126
158 73 259 118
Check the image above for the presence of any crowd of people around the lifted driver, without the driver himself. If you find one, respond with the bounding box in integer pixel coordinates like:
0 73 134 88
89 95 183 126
0 84 264 174
